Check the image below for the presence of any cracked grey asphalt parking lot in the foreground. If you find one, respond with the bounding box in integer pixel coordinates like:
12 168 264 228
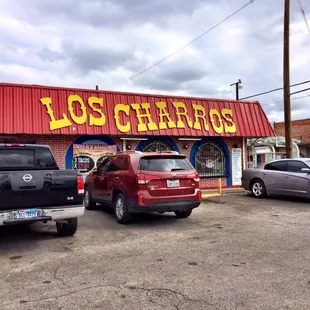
0 193 310 310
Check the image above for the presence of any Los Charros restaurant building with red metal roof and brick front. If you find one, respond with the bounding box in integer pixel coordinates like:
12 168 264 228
0 83 274 188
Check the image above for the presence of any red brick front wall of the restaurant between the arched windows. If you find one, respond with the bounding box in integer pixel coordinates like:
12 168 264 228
13 135 242 188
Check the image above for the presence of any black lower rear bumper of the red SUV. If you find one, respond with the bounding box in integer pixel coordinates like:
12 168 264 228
128 200 200 213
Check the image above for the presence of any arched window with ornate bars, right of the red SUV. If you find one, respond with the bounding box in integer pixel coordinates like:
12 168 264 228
195 142 227 177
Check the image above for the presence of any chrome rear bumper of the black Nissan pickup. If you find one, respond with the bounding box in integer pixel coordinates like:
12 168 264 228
0 205 85 226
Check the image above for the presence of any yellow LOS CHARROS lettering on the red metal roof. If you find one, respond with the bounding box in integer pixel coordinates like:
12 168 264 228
40 95 236 134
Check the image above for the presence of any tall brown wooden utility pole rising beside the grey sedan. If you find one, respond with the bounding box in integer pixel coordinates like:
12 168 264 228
283 0 292 158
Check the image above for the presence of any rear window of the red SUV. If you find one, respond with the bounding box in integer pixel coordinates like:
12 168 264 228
138 156 194 172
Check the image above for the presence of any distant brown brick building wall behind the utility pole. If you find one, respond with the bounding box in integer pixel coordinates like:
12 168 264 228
274 119 310 142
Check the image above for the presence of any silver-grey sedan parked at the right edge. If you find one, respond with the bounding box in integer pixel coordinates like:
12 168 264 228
242 158 310 198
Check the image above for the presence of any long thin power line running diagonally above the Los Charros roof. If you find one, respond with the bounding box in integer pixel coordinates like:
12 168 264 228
106 0 255 90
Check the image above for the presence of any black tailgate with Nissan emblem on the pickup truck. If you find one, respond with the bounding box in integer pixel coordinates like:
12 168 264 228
0 170 83 210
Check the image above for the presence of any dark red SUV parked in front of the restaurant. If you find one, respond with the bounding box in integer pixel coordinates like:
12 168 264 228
84 151 201 224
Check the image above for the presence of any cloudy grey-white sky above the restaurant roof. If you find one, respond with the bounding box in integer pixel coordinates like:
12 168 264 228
0 0 310 121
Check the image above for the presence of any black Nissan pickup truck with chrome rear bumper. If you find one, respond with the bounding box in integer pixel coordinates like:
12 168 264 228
0 144 84 236
